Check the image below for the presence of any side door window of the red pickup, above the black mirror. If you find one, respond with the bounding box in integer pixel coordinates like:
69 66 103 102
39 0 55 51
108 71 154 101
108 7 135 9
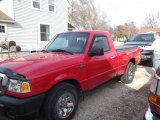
91 36 110 52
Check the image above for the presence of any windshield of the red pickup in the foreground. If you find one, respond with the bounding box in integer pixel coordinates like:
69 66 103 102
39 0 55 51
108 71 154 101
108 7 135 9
45 32 89 53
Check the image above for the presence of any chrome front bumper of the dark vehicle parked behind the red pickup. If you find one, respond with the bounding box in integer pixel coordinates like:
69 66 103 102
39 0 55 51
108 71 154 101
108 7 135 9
141 50 153 61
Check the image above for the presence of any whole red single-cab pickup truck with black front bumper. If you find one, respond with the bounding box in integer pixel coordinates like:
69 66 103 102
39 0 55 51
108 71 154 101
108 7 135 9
0 30 141 120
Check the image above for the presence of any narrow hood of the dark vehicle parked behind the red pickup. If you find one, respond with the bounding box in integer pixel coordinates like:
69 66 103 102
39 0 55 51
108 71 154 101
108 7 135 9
124 42 153 46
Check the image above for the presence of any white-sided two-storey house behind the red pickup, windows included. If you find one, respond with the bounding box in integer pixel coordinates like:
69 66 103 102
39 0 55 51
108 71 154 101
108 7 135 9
0 0 68 50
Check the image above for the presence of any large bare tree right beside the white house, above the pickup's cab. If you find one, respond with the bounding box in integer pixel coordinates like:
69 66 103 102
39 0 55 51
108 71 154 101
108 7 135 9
69 0 110 30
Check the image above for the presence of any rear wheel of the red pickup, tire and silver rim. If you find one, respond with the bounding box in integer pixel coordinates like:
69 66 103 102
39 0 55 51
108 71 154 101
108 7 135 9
121 62 136 84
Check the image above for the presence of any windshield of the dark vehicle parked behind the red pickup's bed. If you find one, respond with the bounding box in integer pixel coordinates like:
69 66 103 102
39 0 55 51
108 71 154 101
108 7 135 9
128 34 155 42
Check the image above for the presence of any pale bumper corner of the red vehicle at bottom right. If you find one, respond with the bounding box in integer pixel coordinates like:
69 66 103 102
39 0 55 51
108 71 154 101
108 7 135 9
145 107 160 120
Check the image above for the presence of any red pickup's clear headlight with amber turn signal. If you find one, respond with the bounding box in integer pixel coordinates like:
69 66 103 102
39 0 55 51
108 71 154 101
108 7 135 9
8 79 31 93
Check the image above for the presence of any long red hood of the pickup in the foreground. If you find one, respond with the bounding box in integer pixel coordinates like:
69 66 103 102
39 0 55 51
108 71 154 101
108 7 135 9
0 52 83 77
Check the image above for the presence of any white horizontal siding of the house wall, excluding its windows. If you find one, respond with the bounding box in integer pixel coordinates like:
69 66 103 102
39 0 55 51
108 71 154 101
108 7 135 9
8 0 68 50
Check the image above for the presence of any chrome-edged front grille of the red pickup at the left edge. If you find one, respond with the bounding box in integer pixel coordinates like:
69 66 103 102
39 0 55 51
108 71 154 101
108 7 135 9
0 73 9 95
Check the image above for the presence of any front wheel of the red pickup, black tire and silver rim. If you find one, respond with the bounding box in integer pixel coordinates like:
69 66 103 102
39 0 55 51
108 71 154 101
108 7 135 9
42 83 79 120
